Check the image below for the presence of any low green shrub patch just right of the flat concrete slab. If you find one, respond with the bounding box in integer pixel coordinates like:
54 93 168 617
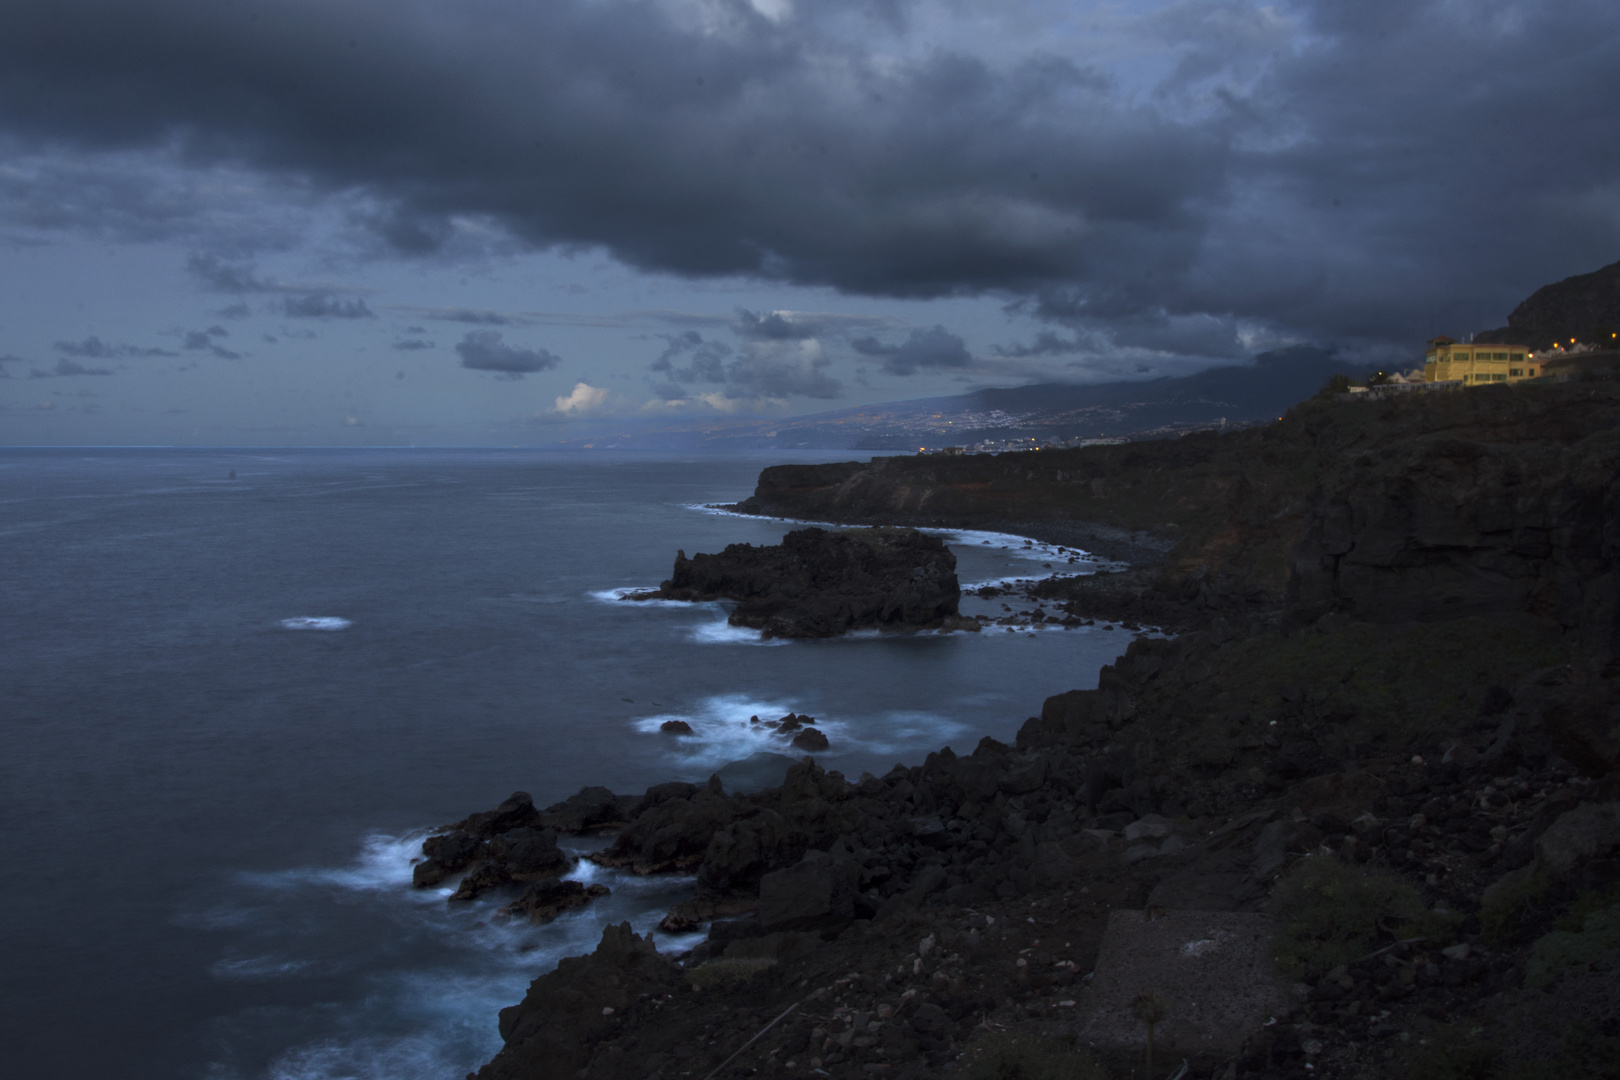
1272 855 1460 978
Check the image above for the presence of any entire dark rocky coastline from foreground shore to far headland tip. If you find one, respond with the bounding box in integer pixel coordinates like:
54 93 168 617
424 381 1620 1080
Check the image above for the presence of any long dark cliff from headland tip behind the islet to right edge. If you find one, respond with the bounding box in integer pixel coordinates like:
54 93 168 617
739 382 1620 651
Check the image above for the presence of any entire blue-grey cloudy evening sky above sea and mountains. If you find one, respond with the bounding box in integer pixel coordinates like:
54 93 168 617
0 0 1620 445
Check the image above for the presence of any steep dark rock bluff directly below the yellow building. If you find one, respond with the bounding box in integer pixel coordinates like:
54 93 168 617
1288 401 1620 654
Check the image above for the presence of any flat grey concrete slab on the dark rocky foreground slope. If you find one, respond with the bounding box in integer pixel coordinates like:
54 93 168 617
1079 912 1291 1061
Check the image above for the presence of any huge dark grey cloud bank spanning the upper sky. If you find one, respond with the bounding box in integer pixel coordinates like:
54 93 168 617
0 0 1620 355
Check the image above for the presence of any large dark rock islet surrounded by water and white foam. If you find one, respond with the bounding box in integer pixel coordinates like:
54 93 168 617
632 528 977 638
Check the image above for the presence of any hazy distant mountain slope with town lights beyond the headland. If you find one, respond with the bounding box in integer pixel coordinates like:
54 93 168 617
570 347 1367 450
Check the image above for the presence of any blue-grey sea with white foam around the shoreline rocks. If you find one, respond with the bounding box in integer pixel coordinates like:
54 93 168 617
0 450 1128 1080
